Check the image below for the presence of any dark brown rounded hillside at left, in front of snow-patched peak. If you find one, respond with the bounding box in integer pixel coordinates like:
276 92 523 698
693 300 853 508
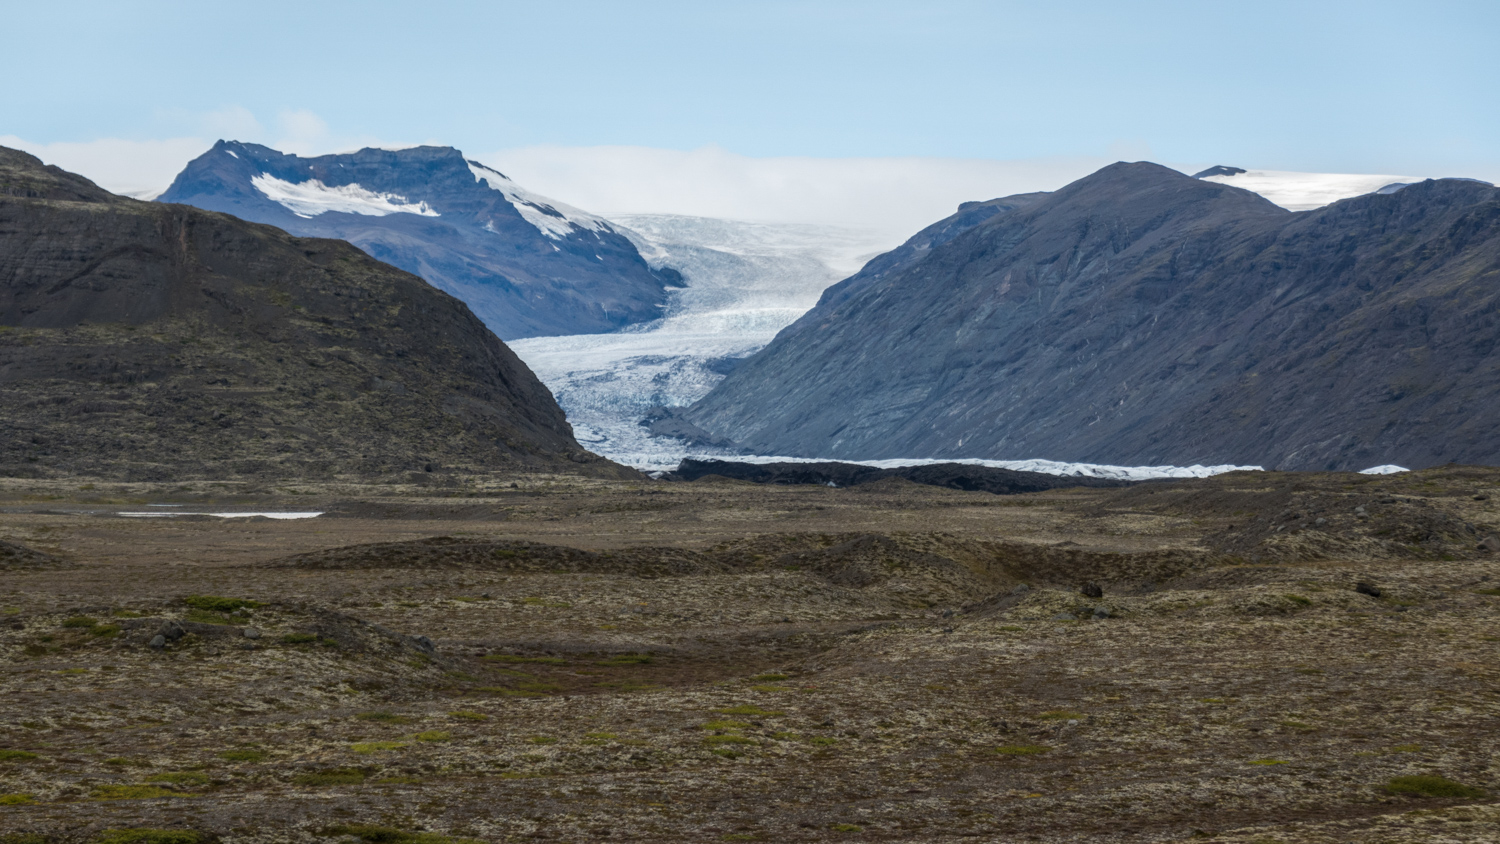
0 147 629 480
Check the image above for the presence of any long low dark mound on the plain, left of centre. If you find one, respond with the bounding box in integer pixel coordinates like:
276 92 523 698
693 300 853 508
269 537 731 577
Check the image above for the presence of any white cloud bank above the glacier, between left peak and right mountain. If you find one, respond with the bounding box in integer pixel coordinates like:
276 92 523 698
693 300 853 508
470 145 1113 234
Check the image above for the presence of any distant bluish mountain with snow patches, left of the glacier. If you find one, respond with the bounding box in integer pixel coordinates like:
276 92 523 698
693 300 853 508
158 141 683 340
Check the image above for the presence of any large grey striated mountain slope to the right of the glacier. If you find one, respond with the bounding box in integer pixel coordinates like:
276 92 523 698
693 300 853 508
683 163 1500 469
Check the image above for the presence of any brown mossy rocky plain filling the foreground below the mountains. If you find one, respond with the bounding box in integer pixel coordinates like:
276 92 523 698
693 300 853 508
0 466 1500 844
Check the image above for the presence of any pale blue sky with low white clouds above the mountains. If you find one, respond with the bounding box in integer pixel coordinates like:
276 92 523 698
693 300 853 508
0 0 1500 225
